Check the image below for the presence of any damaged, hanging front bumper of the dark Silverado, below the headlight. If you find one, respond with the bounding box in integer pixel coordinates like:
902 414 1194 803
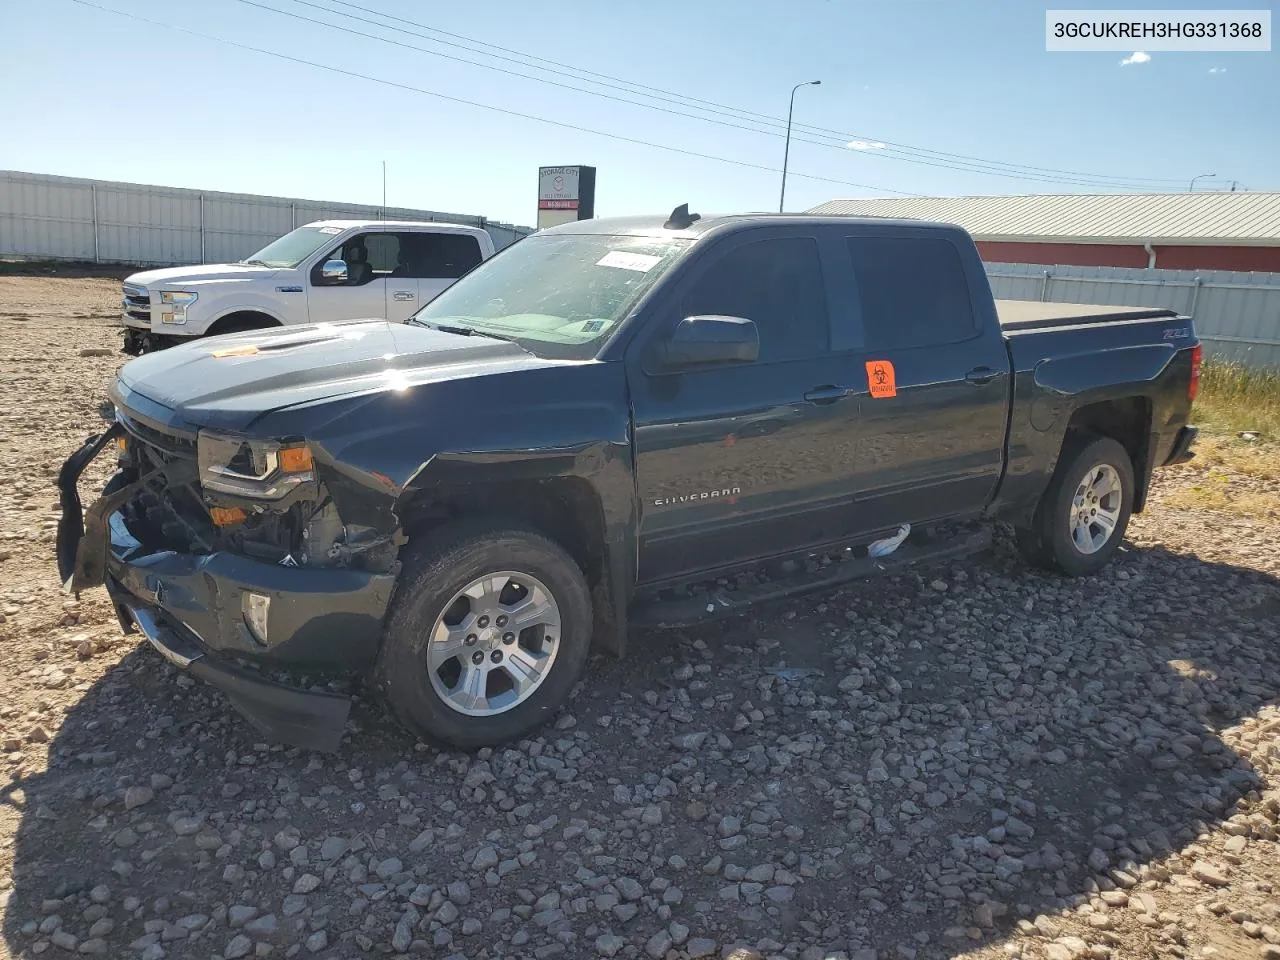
58 425 394 750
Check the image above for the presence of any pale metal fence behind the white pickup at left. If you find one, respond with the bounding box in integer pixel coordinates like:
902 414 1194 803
0 170 532 265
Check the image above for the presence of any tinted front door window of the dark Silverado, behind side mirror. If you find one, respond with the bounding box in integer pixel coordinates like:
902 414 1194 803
682 237 831 364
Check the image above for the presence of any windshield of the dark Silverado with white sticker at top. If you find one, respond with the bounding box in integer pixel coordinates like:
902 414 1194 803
411 234 690 360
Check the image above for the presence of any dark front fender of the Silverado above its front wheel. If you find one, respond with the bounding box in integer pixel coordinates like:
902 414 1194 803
291 362 637 650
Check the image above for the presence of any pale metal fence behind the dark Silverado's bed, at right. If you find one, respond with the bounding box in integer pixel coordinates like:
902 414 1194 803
986 264 1280 367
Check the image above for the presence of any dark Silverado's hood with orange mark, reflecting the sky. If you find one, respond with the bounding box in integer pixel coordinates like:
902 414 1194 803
114 320 558 430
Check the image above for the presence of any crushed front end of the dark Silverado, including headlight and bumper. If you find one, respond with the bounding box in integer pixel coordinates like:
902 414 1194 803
58 398 399 750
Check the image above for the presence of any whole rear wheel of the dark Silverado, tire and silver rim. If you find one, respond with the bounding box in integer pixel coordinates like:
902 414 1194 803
1018 435 1134 576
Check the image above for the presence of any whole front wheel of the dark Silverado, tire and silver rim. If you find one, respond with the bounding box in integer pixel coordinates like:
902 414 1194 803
378 525 591 749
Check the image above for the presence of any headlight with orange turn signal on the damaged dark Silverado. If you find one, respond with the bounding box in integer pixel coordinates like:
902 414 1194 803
196 430 315 500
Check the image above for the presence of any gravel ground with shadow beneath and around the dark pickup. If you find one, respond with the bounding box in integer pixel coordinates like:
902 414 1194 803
0 276 1280 960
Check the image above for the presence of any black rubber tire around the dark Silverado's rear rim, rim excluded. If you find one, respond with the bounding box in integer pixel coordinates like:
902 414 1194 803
1016 434 1135 577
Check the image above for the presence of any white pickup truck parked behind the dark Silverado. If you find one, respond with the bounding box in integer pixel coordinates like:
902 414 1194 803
122 220 493 356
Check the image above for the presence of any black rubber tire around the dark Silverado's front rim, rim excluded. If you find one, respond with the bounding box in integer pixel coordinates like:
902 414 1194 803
376 522 593 750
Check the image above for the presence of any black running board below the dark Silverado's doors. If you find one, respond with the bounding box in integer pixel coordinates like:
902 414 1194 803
627 527 992 628
